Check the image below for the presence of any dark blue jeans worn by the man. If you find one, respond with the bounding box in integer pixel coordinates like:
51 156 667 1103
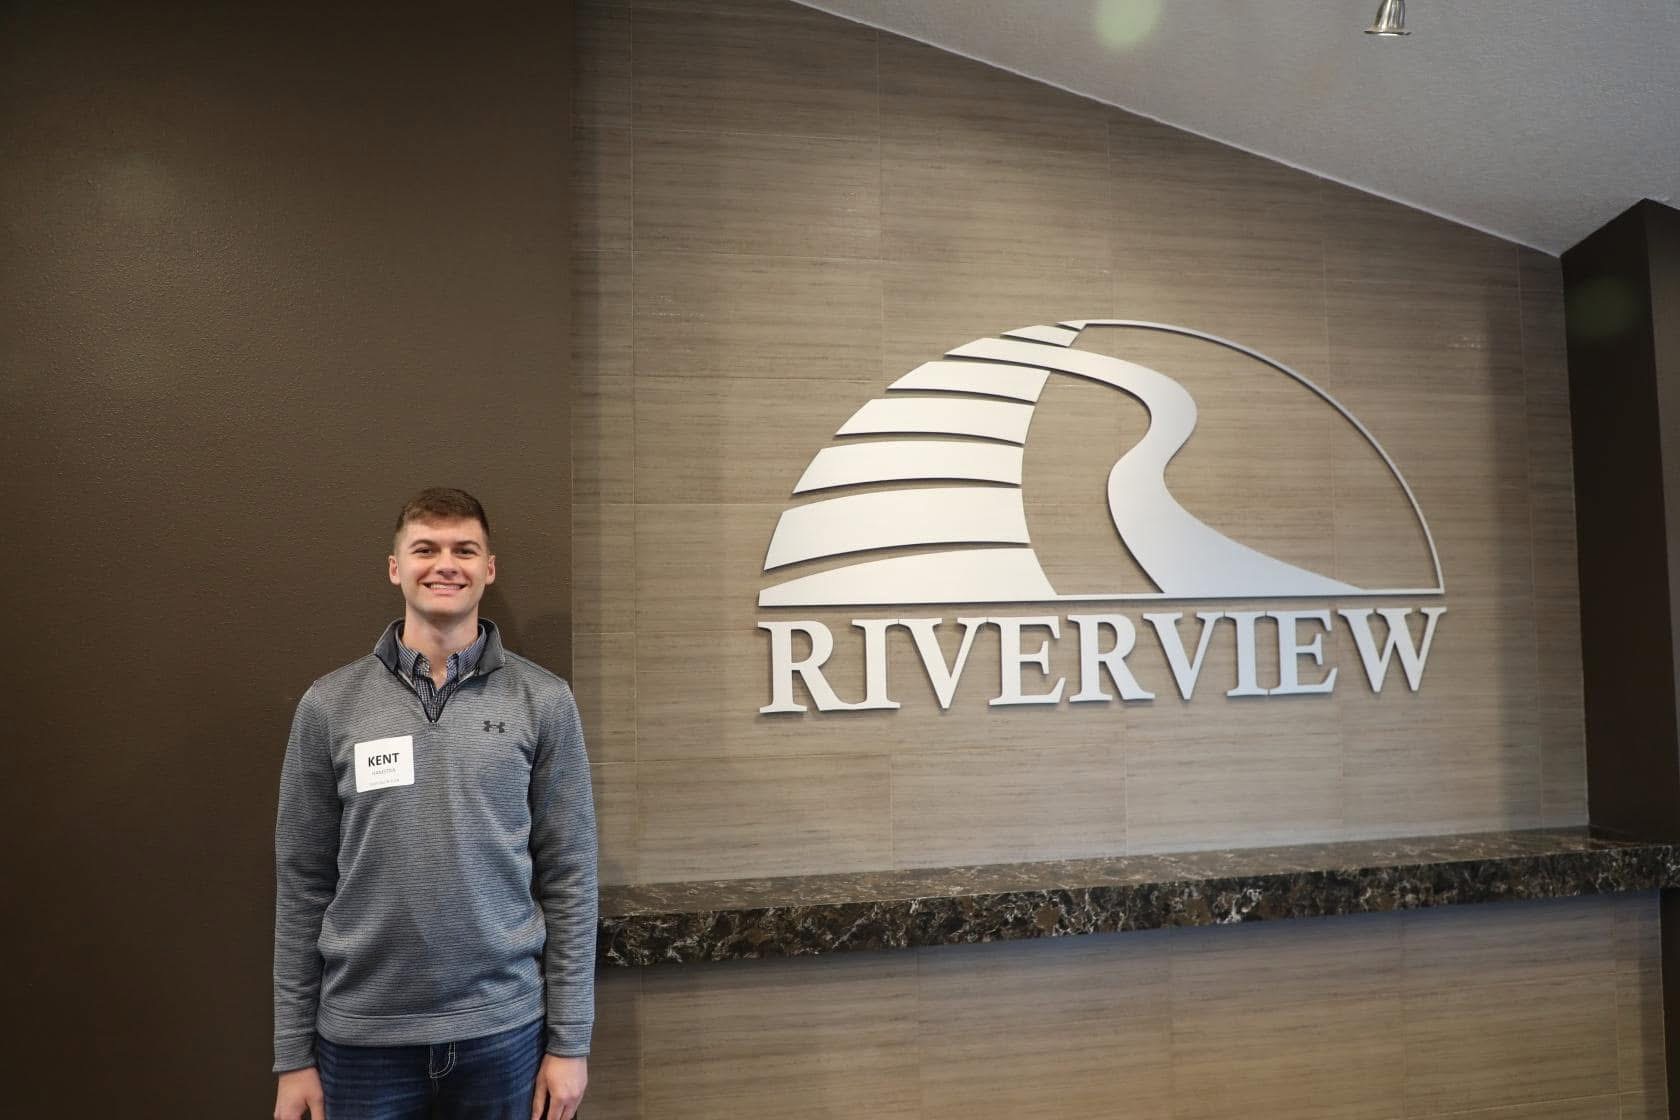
316 1019 546 1120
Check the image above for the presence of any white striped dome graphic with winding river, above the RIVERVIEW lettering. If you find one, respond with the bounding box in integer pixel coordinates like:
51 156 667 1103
758 319 1445 606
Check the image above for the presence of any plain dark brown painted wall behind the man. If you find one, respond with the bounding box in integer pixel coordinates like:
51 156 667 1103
0 2 571 1117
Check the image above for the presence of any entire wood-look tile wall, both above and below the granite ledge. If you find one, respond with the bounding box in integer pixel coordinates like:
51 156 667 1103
573 0 1665 1120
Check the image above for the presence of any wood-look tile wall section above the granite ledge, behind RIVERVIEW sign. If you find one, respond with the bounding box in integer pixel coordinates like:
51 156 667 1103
573 0 1586 882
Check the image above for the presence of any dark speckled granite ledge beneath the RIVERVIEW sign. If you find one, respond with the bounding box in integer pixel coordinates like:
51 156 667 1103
600 828 1680 966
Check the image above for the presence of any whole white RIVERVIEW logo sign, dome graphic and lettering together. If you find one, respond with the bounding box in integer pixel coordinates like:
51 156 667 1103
758 319 1446 712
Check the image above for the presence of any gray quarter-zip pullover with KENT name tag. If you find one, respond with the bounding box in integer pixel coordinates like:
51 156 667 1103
274 623 596 1071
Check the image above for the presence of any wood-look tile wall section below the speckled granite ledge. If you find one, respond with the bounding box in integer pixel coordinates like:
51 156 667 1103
586 895 1667 1120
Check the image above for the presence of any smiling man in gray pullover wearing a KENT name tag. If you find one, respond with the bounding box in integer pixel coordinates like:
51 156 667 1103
274 489 596 1120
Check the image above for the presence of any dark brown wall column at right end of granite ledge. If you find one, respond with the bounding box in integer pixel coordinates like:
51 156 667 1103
1562 201 1680 840
